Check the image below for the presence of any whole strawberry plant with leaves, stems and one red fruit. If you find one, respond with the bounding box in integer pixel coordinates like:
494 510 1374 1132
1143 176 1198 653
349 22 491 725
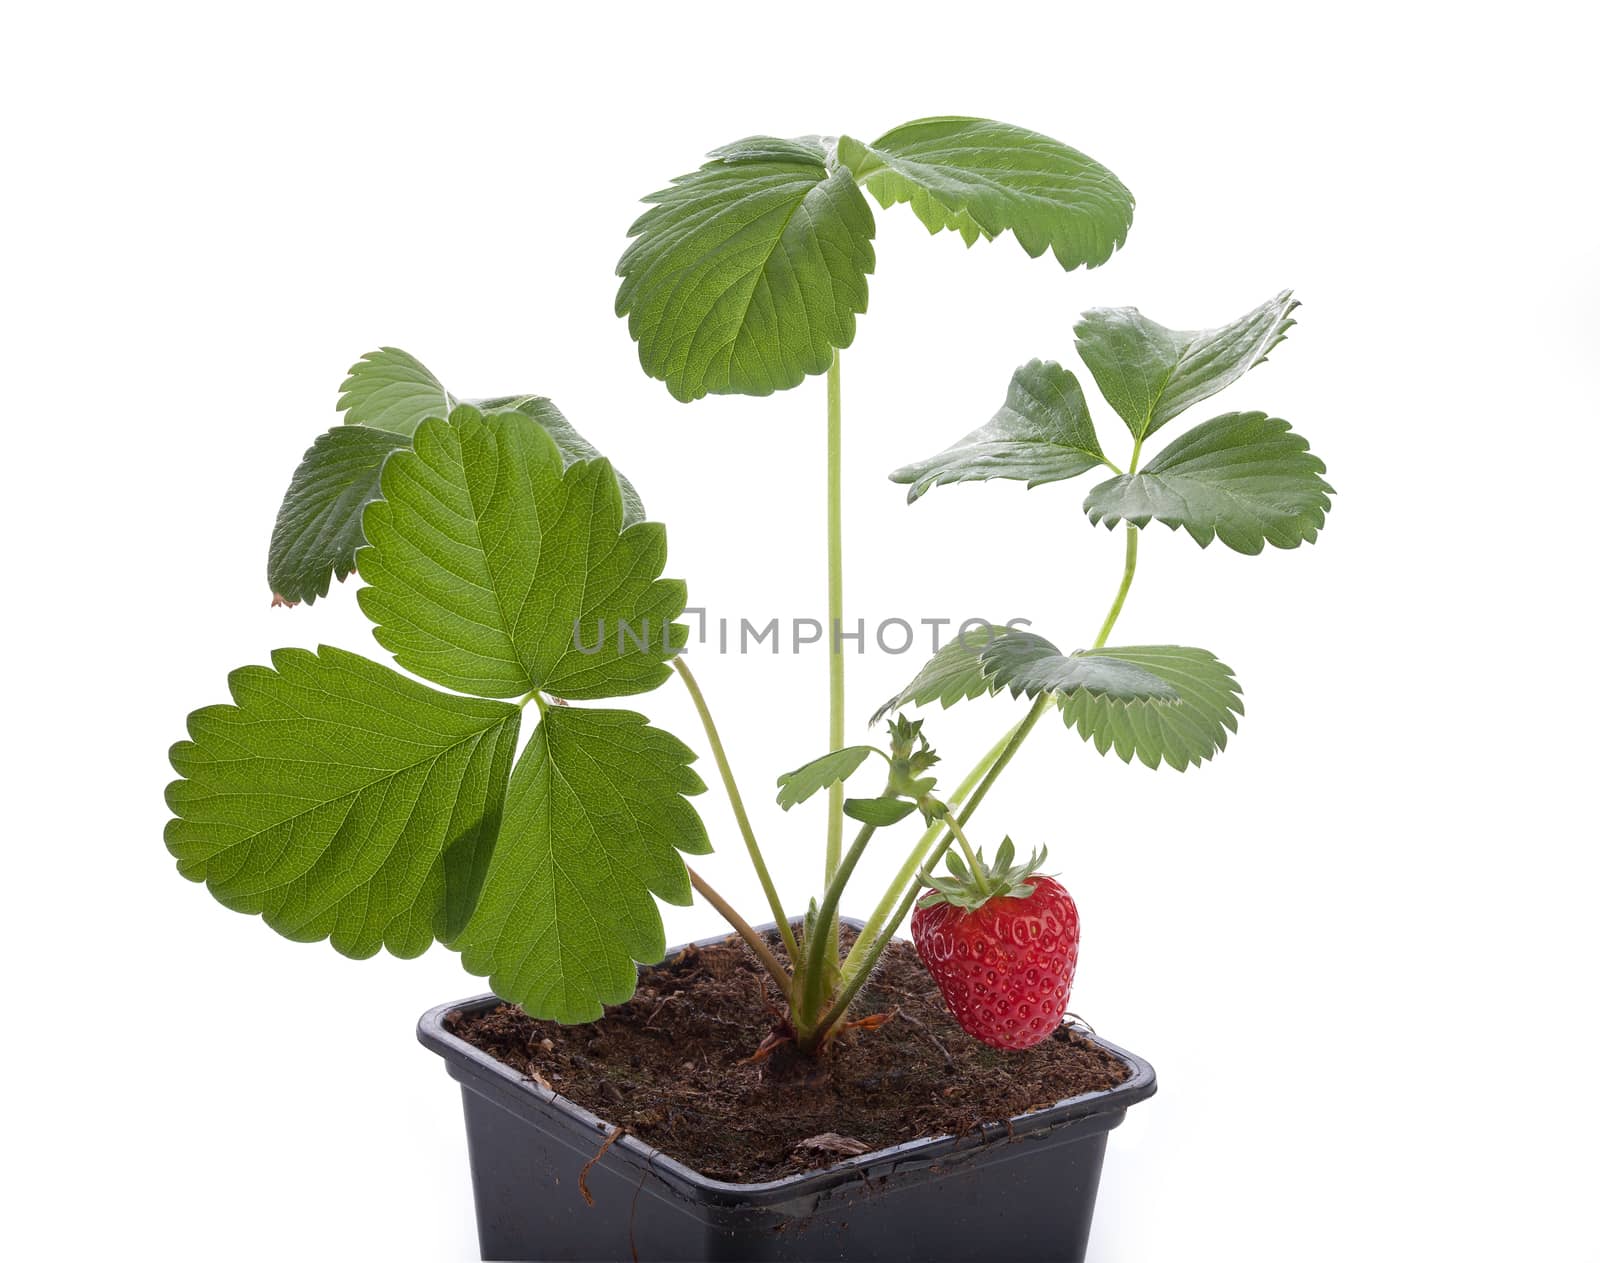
166 118 1331 1055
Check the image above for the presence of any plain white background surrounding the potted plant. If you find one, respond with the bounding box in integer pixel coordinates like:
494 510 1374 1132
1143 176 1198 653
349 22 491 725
0 3 1600 1263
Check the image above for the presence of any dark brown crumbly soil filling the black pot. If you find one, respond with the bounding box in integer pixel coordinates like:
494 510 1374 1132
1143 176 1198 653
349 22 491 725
446 928 1128 1183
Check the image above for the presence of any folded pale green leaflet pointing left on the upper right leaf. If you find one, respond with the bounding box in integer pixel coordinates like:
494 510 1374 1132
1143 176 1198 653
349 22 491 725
890 360 1106 504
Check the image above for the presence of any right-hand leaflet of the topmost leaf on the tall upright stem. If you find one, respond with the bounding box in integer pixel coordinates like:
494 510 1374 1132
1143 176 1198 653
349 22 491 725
838 118 1133 271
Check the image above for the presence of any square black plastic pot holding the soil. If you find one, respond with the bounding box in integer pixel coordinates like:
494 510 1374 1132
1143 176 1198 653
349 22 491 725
418 922 1155 1263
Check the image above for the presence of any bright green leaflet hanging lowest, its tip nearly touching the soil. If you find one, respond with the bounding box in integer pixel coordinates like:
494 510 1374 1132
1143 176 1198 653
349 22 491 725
451 706 710 1023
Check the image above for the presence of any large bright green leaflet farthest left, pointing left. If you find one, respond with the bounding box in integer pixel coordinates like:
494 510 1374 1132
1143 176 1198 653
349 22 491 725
166 645 520 957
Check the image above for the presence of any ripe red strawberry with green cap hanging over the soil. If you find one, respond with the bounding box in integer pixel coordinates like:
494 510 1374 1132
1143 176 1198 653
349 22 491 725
910 839 1078 1048
